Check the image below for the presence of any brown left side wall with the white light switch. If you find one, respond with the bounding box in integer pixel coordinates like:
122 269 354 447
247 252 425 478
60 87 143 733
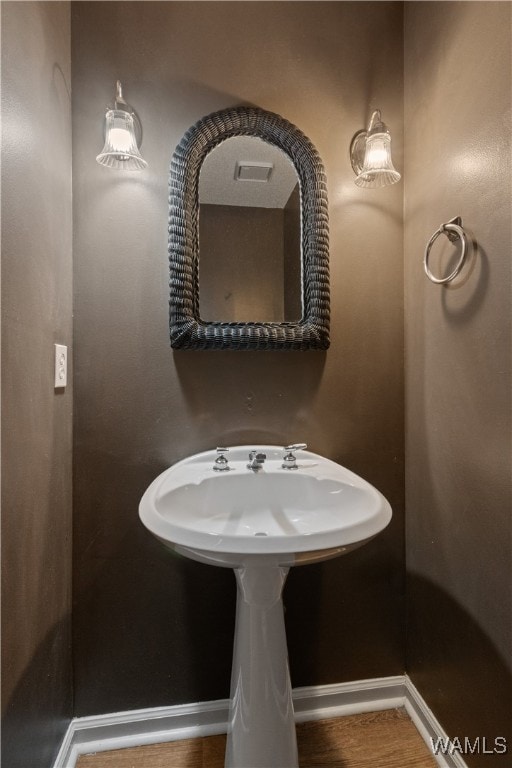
1 2 72 768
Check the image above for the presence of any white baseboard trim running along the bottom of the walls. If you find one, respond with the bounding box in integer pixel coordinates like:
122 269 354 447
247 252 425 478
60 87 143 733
54 675 467 768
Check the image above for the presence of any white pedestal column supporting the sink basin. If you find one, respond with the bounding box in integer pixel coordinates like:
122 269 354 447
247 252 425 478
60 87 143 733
225 565 299 768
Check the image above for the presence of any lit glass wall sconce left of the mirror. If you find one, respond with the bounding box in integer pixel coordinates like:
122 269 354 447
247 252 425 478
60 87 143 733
96 80 148 171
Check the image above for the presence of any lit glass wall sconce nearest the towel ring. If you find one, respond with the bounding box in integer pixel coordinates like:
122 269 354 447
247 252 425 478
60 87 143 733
350 109 401 188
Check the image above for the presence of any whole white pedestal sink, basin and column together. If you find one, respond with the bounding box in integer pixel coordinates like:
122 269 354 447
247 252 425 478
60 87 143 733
139 445 391 768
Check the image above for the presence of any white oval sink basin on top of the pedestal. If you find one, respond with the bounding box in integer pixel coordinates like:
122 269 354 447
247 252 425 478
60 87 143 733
140 445 391 567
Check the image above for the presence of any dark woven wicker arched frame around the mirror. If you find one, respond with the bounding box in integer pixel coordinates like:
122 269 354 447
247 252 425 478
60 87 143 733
169 107 330 350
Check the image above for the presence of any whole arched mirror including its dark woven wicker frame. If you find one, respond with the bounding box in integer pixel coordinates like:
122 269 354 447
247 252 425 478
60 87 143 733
169 107 329 349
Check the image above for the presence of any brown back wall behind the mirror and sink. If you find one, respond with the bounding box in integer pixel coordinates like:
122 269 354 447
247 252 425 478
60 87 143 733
72 2 404 715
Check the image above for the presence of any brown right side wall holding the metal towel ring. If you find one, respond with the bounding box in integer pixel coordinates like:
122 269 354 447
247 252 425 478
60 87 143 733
404 2 512 768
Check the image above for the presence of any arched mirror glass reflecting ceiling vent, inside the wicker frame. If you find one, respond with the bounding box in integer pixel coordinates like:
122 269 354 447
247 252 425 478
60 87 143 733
199 136 303 323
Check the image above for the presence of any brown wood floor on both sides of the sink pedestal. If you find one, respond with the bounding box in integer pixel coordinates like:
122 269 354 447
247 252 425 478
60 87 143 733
77 709 436 768
